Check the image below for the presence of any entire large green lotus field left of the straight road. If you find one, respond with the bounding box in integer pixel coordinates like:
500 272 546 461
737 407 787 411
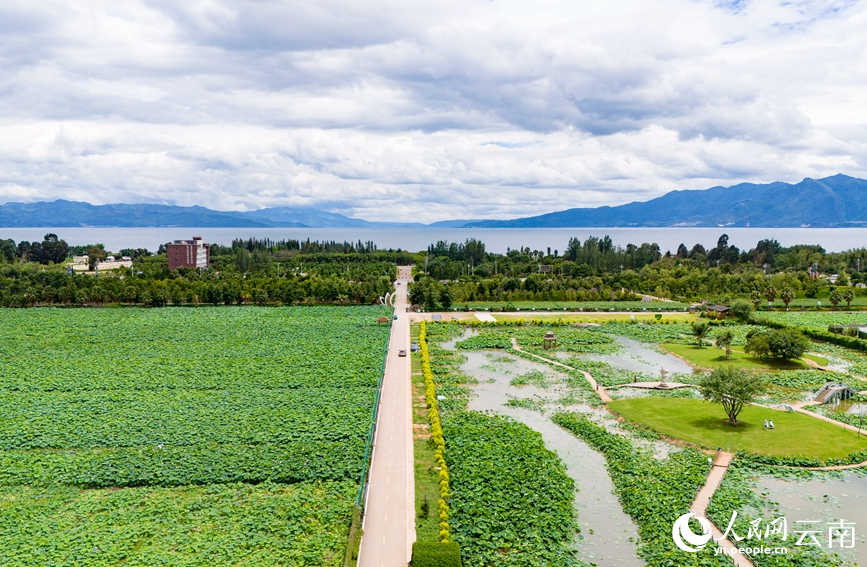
0 307 388 567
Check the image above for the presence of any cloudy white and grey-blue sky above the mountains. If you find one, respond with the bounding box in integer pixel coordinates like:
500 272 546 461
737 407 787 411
0 0 867 222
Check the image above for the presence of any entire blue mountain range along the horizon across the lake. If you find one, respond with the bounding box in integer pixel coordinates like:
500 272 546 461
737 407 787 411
0 174 867 228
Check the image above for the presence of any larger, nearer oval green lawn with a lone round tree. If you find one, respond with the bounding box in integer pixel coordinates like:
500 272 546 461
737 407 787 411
608 397 867 460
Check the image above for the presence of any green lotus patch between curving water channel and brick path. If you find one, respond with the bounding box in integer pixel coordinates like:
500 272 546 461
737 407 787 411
552 413 730 567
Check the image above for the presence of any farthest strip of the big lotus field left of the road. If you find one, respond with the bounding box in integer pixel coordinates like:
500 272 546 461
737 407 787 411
0 307 388 391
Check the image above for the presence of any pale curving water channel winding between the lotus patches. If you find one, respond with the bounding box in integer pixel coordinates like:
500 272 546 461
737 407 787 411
458 350 644 567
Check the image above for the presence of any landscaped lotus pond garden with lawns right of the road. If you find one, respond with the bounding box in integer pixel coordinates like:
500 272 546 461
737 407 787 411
416 314 867 567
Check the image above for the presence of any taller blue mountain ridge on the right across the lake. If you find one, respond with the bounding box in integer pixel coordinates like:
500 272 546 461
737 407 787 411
465 175 867 228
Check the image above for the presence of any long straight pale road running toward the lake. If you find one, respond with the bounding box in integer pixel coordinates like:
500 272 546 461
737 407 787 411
358 266 415 567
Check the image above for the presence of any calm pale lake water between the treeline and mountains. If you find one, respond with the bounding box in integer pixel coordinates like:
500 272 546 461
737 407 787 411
0 228 867 254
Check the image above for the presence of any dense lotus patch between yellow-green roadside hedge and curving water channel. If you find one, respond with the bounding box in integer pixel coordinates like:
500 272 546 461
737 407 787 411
443 411 577 567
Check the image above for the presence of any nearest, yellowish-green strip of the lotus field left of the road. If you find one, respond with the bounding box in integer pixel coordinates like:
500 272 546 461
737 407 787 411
0 481 357 567
